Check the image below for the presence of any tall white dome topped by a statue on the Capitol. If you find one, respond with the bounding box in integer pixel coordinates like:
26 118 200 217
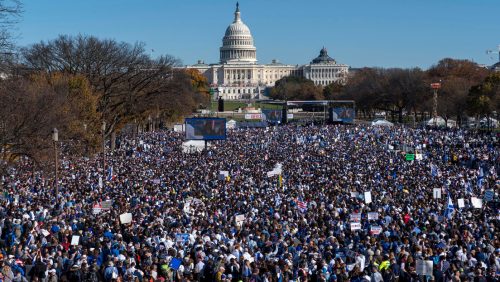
220 3 257 64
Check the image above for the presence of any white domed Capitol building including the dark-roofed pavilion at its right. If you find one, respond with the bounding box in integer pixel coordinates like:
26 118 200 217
185 3 349 100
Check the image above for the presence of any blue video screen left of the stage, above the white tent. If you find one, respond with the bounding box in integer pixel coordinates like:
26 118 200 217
185 118 226 140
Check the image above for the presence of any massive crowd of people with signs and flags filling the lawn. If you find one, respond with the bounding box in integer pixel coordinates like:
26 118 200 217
0 125 500 282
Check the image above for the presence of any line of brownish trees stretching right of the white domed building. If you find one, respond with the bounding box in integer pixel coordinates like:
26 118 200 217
270 58 500 124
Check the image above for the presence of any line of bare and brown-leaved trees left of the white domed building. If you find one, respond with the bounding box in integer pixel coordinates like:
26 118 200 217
0 35 209 172
